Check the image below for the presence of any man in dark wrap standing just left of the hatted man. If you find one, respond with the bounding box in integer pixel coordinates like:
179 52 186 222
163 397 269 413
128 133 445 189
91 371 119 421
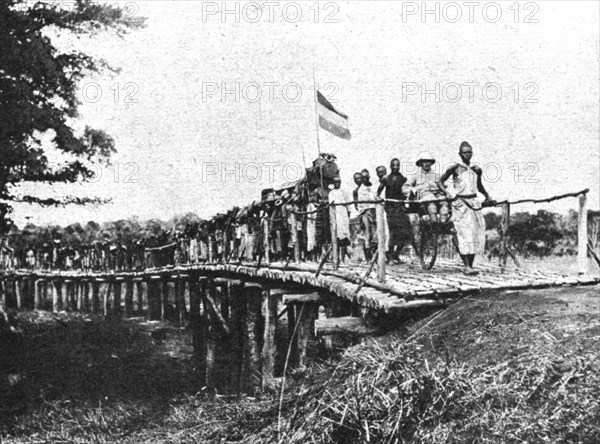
377 159 413 262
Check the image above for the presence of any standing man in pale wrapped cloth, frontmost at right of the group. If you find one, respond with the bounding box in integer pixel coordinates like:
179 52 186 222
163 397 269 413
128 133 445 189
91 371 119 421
438 142 492 275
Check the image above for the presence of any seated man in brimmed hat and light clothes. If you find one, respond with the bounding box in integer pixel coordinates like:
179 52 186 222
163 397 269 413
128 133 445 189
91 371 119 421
406 151 450 222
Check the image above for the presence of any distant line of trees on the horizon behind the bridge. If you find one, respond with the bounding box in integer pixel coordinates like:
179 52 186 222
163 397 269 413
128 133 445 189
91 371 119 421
2 210 600 257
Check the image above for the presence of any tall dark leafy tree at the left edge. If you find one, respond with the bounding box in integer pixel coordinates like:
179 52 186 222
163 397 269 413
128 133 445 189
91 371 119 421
0 0 143 233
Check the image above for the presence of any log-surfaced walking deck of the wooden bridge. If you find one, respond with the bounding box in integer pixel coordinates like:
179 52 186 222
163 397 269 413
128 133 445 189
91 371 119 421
5 259 600 312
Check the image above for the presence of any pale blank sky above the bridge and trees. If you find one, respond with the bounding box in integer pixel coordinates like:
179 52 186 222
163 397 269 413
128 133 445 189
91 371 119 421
14 0 600 225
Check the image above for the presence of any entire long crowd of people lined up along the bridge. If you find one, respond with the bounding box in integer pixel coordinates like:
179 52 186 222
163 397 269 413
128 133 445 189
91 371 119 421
1 142 491 274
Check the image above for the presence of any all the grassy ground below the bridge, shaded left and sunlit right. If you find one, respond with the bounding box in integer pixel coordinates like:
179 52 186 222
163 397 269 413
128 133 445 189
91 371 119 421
2 286 600 444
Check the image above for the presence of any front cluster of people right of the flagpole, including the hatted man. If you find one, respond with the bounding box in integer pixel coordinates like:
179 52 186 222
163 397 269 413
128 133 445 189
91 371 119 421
329 142 493 275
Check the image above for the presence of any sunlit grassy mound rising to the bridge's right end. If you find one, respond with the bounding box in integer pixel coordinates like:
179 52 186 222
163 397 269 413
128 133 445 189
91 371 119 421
266 286 600 443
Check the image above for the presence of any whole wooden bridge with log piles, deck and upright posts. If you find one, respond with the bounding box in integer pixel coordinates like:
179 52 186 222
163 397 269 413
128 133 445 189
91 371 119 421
0 190 600 393
